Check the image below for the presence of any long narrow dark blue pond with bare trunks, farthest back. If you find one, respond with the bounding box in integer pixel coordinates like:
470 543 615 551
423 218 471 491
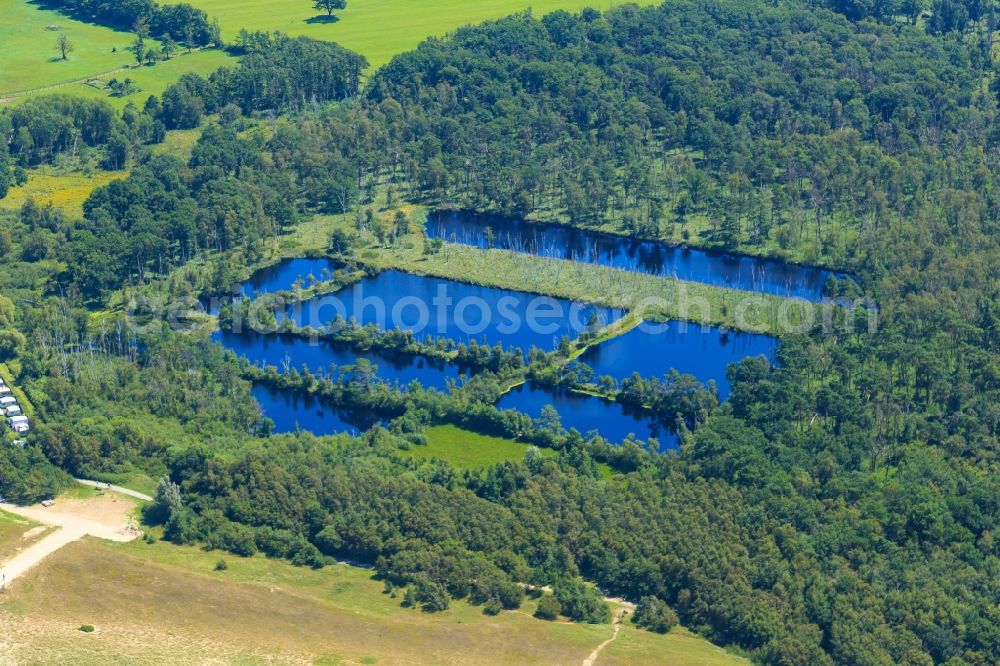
426 211 845 301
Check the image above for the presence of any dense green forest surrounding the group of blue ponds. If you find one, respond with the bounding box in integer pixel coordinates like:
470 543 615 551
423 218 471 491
0 0 1000 666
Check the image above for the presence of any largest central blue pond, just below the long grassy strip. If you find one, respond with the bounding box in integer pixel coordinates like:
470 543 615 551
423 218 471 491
286 271 624 351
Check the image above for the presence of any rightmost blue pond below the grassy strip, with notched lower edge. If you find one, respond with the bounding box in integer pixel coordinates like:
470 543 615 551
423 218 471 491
579 321 778 399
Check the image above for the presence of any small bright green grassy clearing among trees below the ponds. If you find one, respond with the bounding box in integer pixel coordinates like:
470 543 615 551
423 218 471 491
400 425 554 469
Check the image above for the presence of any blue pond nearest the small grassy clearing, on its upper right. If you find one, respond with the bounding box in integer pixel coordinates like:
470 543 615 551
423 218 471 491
497 384 677 449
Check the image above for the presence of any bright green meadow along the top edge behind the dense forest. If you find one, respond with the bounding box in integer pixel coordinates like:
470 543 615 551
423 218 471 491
191 0 664 69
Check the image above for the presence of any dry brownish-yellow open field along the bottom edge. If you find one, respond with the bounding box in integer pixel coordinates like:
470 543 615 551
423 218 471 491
0 539 742 666
